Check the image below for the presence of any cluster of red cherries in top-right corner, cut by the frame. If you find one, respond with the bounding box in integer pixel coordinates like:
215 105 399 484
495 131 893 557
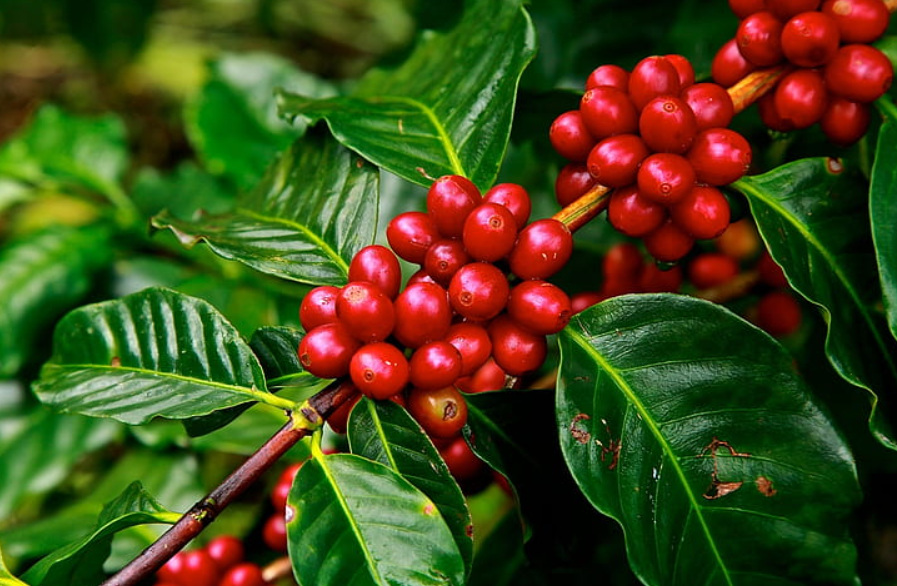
712 0 894 146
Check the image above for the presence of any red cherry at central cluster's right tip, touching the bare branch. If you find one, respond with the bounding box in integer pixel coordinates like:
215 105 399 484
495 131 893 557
508 218 573 279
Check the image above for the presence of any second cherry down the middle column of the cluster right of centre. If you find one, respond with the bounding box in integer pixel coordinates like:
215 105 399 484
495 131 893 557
639 96 698 154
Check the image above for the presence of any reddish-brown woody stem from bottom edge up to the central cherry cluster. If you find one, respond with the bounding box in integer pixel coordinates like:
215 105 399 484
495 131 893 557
102 379 358 586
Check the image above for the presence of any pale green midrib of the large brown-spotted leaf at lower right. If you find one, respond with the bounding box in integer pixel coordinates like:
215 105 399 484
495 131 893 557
566 327 734 586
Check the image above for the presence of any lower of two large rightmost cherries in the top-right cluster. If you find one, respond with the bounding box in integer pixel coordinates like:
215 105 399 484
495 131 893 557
825 45 894 102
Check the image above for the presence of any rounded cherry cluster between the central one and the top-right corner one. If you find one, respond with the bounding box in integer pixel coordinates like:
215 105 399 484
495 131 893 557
549 55 751 262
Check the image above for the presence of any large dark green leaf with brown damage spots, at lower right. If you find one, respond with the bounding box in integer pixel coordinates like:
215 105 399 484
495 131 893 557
557 294 860 585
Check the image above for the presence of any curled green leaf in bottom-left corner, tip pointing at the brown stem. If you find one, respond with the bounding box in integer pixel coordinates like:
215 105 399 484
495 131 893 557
22 482 179 586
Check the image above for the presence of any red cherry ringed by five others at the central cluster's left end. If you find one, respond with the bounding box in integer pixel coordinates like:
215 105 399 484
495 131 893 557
336 281 396 342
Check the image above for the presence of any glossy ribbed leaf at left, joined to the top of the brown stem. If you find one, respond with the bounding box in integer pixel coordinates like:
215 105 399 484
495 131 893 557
34 288 292 425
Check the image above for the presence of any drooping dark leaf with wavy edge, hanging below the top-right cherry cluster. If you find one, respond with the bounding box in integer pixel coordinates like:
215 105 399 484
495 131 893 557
733 158 897 449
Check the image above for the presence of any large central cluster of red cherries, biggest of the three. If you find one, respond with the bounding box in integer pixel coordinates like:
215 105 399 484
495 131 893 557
298 175 573 439
